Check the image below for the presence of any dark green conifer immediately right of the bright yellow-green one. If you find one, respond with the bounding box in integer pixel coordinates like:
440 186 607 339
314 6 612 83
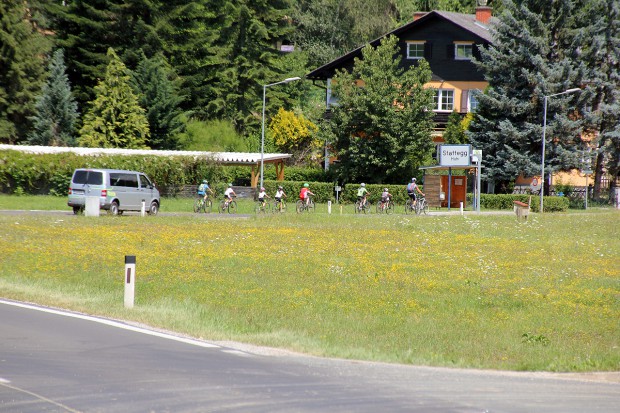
132 55 185 149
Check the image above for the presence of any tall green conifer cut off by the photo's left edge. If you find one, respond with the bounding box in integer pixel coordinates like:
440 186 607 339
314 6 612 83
0 0 49 143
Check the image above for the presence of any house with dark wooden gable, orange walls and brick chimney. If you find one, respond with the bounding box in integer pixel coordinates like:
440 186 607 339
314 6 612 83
306 6 495 143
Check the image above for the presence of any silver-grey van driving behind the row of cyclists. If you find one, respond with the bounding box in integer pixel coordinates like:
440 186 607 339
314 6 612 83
67 169 160 215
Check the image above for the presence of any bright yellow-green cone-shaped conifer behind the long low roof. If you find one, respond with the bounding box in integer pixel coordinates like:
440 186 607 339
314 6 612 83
78 48 149 149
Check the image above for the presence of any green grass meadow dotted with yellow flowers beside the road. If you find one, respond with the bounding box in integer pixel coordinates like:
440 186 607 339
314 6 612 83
0 196 620 371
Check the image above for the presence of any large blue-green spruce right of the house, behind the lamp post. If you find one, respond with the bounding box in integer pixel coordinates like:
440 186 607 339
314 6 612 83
470 0 583 191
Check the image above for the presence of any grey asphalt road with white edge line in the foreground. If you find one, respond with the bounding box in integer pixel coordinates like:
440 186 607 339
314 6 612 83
0 300 620 413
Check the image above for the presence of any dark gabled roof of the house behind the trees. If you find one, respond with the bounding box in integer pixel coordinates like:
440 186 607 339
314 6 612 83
306 11 497 80
